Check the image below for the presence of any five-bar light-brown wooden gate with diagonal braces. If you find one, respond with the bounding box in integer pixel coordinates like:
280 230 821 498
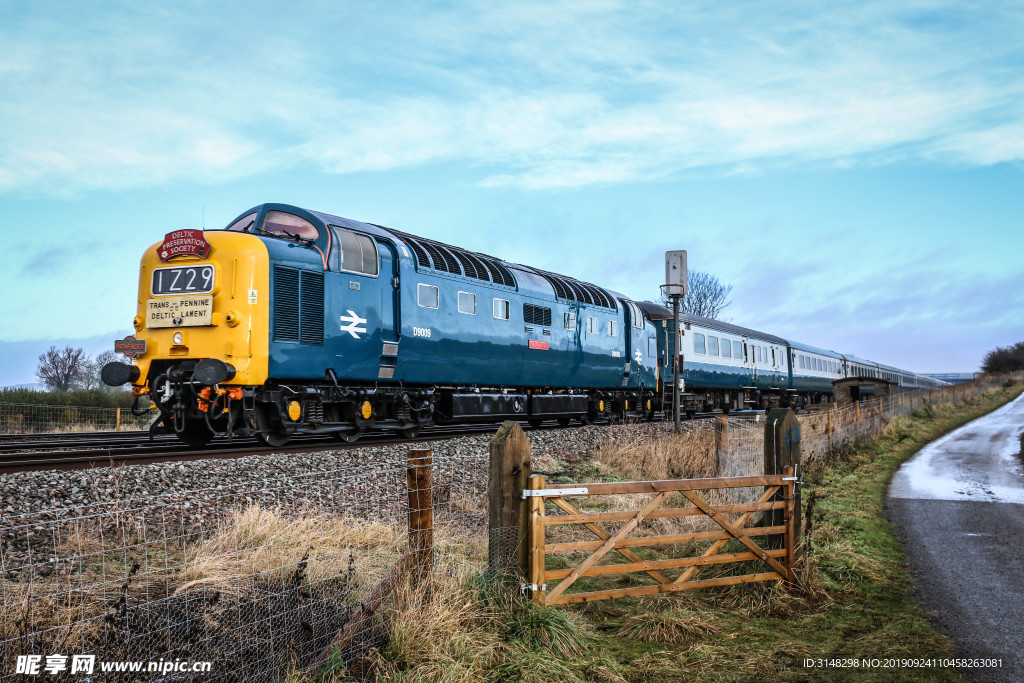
523 466 797 605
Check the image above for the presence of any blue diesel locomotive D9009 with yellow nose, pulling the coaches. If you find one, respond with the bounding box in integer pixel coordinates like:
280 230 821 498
103 204 659 446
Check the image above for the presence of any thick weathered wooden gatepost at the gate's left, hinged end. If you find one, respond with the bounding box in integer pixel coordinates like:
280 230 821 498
487 421 532 577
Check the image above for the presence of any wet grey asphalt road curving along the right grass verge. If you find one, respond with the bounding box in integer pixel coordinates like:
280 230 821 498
886 395 1024 681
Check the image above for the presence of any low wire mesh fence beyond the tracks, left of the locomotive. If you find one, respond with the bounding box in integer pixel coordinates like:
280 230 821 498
0 403 157 434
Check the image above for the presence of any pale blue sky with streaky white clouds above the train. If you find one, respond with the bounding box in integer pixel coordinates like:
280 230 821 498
0 0 1024 385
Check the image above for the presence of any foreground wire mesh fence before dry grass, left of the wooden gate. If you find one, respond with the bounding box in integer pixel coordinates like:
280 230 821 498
0 455 486 681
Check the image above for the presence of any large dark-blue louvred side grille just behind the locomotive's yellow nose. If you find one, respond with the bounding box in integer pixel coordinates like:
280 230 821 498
273 265 324 344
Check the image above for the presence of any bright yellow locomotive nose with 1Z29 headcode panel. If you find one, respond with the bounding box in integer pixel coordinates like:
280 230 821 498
132 230 270 387
